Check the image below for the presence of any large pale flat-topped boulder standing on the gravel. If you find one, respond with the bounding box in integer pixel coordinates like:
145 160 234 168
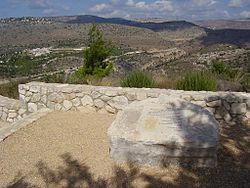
108 95 219 167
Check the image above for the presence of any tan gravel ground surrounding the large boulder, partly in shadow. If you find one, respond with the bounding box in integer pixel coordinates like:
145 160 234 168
0 112 250 188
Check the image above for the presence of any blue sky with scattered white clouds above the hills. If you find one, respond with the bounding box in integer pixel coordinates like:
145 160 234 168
0 0 250 20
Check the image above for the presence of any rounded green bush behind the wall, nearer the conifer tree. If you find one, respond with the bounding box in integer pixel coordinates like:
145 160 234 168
121 70 155 88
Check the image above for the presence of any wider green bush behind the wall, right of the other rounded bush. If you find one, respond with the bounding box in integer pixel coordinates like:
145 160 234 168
177 72 216 91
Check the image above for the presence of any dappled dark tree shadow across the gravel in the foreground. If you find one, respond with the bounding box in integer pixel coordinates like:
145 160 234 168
7 121 250 188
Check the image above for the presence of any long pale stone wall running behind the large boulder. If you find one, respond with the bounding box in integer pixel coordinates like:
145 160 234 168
19 82 250 123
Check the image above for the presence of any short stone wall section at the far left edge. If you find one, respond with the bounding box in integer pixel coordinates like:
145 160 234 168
0 95 26 123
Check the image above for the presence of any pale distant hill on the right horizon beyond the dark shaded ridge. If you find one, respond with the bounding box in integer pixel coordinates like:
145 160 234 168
195 19 250 30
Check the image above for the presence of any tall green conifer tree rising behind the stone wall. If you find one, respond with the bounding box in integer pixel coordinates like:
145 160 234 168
81 24 113 77
